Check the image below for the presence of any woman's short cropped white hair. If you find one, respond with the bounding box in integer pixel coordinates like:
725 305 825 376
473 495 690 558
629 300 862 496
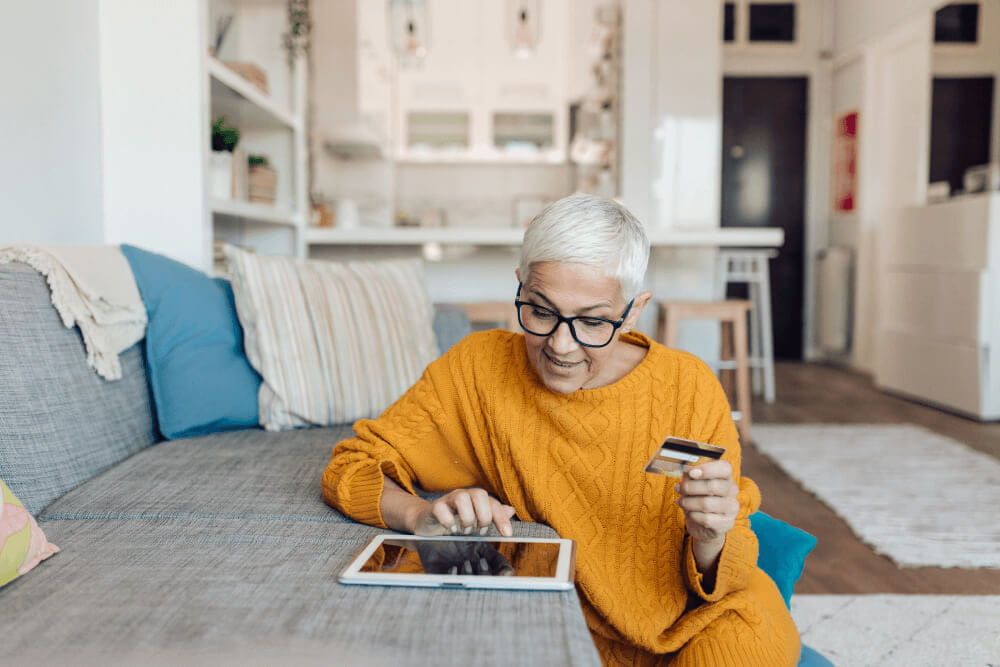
519 193 649 300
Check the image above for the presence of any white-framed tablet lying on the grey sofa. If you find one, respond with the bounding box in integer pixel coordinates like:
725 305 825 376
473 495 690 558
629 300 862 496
338 535 575 591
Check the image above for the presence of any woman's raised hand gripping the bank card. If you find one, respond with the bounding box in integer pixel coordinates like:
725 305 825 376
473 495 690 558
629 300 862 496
676 461 740 553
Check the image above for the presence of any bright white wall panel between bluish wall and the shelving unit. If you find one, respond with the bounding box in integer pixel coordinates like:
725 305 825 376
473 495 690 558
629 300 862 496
100 0 211 269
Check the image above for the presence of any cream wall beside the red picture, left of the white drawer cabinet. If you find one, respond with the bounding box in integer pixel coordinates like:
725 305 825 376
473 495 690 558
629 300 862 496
831 6 940 372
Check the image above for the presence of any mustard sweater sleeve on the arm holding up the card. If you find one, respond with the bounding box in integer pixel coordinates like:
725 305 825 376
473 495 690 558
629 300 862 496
684 367 760 602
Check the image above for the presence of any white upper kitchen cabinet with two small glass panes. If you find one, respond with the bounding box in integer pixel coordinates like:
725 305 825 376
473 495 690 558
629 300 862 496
388 0 570 163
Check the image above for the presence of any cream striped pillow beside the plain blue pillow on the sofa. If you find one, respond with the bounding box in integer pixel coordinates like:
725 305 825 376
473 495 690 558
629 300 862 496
226 247 437 431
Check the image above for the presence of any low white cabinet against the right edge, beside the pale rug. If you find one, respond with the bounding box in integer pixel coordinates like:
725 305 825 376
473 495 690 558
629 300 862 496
875 193 1000 420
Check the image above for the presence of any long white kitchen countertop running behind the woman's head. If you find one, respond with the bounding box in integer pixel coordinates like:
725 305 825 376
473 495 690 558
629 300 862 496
306 227 784 248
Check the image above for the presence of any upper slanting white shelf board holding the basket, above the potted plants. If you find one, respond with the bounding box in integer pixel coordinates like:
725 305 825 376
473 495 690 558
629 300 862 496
208 57 302 130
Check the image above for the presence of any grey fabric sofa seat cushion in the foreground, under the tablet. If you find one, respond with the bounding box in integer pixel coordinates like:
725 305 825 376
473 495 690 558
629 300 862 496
0 518 599 665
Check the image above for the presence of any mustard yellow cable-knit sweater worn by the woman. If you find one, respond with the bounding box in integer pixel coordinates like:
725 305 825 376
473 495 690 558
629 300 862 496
323 331 799 667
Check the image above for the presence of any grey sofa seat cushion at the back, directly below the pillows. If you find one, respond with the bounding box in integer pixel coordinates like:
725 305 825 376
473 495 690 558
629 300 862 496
40 426 360 522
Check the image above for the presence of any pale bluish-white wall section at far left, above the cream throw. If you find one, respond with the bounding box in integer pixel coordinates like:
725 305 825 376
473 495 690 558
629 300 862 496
0 0 103 244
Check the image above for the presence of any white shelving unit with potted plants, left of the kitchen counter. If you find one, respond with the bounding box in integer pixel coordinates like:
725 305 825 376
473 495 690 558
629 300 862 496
204 0 309 264
